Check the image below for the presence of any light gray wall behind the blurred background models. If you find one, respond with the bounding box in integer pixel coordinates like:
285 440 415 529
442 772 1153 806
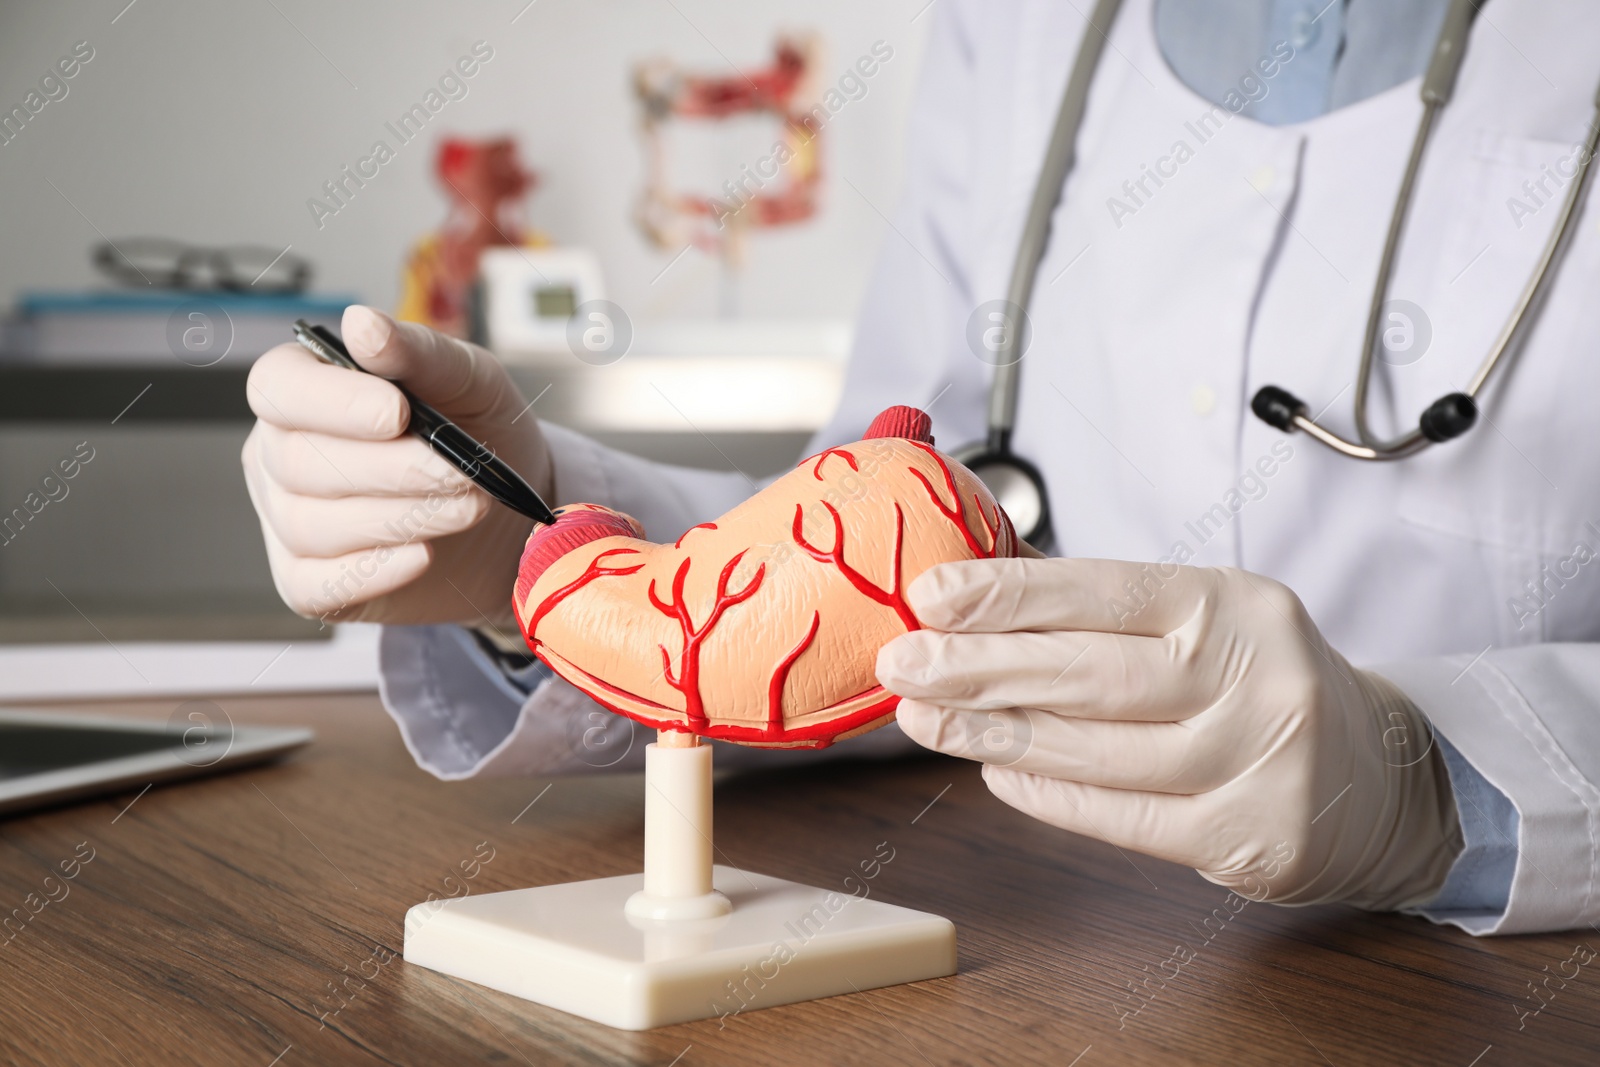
0 0 931 318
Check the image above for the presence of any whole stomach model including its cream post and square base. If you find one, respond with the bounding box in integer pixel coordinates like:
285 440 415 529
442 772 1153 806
405 408 979 1030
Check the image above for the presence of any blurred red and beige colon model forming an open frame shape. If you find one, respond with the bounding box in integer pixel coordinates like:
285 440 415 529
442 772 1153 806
634 35 827 303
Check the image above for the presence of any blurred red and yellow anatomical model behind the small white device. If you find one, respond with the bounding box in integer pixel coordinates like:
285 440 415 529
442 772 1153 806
397 138 549 338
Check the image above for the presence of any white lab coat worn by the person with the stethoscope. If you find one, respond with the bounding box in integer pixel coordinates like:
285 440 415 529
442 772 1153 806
384 0 1600 933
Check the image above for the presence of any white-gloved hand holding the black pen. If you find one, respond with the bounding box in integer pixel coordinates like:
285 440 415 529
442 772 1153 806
243 306 552 627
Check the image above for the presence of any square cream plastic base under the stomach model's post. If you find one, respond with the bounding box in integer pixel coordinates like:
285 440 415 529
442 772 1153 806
405 867 955 1030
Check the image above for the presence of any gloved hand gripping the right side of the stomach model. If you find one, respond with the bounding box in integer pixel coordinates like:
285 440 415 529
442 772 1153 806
878 560 1462 909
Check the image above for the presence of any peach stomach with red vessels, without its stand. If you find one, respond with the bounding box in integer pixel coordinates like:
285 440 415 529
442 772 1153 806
514 408 1018 749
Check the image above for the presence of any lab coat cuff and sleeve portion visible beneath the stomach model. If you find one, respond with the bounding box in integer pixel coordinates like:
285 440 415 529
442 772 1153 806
378 625 917 781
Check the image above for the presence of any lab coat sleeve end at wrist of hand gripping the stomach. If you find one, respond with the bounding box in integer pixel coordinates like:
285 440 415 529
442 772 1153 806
1378 643 1600 934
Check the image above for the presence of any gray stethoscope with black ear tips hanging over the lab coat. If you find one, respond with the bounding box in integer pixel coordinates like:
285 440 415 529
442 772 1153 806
955 0 1600 547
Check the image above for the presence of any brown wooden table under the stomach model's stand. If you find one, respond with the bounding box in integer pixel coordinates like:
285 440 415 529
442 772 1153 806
0 696 1600 1067
